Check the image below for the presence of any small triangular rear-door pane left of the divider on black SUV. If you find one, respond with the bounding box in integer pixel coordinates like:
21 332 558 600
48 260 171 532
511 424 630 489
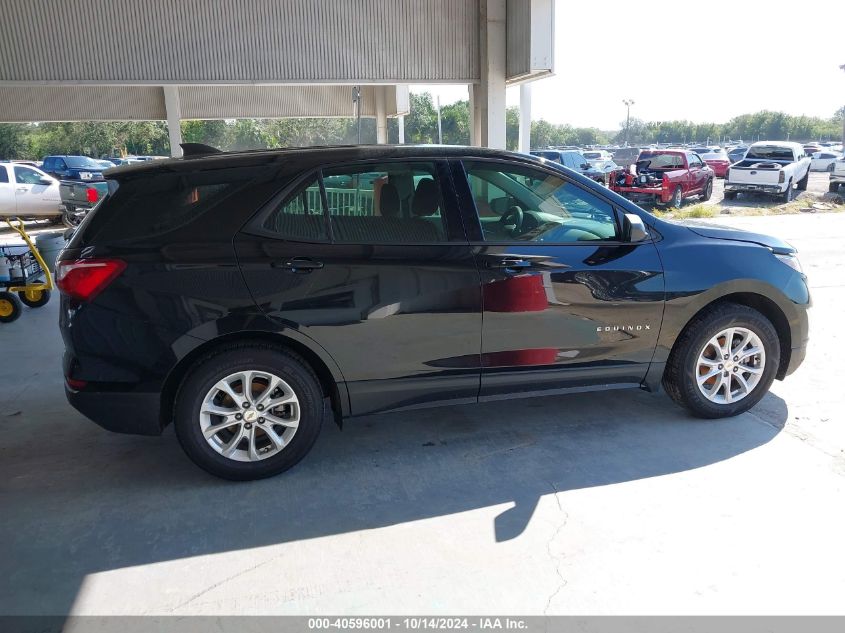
264 175 329 242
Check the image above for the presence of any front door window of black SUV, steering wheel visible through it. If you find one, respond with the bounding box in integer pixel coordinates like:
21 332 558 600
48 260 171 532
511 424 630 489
464 161 618 243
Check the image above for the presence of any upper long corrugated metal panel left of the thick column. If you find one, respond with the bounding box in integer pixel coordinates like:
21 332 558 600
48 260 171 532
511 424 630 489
0 0 479 84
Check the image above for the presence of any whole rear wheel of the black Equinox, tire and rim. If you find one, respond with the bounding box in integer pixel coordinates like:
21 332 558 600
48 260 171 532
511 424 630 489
174 344 323 480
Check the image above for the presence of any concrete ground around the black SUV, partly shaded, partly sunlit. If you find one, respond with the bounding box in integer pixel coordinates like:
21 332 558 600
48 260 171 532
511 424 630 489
0 211 845 615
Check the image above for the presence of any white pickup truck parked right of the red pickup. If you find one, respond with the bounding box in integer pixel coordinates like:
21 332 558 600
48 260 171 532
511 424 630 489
725 141 810 202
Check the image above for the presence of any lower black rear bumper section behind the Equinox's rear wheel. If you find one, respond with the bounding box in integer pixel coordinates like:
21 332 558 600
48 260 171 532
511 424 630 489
65 385 162 435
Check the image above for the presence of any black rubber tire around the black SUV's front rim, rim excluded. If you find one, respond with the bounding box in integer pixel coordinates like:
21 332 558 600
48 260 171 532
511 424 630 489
663 302 780 418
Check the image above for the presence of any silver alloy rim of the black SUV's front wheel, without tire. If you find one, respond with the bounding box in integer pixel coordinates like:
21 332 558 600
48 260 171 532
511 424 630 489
695 327 766 404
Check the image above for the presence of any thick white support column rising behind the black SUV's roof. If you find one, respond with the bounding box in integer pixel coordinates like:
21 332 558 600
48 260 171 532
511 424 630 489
470 0 507 149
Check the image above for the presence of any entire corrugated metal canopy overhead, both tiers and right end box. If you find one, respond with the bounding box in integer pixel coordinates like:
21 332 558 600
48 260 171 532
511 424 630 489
0 0 553 151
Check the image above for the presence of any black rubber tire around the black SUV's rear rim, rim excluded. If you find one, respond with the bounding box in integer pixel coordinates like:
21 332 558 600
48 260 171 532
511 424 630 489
173 343 323 481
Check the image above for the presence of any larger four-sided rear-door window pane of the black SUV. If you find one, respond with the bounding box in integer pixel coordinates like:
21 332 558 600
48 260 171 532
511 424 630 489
323 162 448 244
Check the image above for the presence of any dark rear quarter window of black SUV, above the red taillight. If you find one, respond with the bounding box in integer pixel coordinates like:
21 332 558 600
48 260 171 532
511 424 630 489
84 169 255 243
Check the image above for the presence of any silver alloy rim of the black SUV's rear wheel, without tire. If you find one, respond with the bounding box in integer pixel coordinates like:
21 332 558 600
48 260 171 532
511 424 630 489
199 370 300 462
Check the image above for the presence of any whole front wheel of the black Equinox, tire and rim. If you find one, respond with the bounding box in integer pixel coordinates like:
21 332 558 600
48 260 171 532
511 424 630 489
663 303 780 418
